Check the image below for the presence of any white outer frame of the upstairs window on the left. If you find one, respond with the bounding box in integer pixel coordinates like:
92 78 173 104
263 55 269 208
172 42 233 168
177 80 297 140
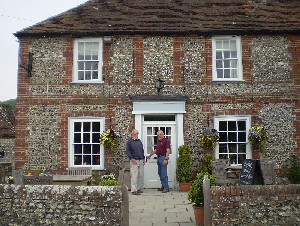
72 38 103 83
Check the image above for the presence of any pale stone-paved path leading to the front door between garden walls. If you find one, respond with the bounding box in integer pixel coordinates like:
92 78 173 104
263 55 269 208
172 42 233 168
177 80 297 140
128 189 196 226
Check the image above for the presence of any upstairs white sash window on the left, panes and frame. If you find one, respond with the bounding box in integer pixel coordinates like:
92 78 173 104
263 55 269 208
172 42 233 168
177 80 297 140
73 38 103 83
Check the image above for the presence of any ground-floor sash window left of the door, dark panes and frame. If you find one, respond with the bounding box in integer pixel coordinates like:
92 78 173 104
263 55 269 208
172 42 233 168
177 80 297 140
69 118 104 169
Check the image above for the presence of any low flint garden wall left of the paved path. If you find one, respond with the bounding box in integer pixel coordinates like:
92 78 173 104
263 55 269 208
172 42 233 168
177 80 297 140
0 184 129 226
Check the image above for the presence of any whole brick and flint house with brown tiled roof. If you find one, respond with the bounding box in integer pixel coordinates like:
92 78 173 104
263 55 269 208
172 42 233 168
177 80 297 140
15 0 300 188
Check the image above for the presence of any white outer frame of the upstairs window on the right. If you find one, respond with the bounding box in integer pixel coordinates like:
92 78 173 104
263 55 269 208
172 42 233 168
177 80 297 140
212 36 243 81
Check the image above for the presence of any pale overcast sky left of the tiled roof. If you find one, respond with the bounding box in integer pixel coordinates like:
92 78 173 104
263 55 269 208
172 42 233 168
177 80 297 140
0 0 88 101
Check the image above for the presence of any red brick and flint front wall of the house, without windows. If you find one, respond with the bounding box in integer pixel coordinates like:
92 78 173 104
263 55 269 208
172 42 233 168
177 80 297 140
15 35 300 173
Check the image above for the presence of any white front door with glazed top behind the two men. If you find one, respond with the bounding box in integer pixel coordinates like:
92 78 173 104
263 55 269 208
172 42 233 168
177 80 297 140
143 121 177 188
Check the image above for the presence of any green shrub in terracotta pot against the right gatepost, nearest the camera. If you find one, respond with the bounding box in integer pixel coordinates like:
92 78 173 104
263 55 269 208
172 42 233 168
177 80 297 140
188 153 216 225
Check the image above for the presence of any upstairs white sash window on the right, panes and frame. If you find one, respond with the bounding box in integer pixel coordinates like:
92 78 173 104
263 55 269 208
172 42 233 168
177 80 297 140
212 36 243 81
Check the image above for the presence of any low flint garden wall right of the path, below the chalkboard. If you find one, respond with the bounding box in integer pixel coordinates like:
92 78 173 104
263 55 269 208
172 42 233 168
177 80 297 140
211 184 300 225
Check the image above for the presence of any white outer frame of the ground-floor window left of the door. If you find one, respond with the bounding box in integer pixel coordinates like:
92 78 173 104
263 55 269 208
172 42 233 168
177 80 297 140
68 117 105 170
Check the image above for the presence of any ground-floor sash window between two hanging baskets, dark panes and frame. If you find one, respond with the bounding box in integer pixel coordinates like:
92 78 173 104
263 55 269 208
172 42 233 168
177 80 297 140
215 116 251 164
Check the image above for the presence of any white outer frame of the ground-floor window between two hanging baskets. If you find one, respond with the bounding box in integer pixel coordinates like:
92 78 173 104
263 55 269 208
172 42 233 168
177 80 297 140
214 115 252 164
